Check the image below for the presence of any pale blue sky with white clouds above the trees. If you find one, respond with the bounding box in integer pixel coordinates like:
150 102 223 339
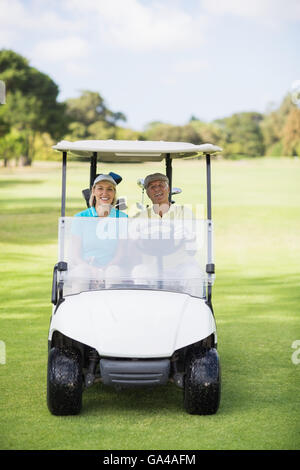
0 0 300 131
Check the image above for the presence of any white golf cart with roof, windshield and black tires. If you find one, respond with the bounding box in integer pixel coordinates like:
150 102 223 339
47 140 222 415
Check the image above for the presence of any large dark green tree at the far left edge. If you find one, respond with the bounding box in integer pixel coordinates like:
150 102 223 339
0 49 67 164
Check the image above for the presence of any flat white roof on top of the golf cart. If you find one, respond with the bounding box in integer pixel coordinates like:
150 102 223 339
53 140 222 162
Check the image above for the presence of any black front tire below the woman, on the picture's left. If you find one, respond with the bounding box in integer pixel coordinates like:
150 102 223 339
47 348 83 416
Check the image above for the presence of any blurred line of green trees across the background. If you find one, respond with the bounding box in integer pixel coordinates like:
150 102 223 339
0 49 300 165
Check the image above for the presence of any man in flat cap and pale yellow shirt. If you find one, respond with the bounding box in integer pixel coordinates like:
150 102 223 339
132 173 203 296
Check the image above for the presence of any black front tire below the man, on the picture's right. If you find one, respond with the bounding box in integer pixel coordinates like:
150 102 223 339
184 348 221 415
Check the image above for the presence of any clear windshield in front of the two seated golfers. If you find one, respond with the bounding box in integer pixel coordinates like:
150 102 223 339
59 217 212 297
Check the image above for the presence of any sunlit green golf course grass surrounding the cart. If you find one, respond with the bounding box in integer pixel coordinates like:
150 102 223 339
0 158 300 450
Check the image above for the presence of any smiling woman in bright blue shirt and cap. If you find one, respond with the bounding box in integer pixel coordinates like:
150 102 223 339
71 175 128 290
